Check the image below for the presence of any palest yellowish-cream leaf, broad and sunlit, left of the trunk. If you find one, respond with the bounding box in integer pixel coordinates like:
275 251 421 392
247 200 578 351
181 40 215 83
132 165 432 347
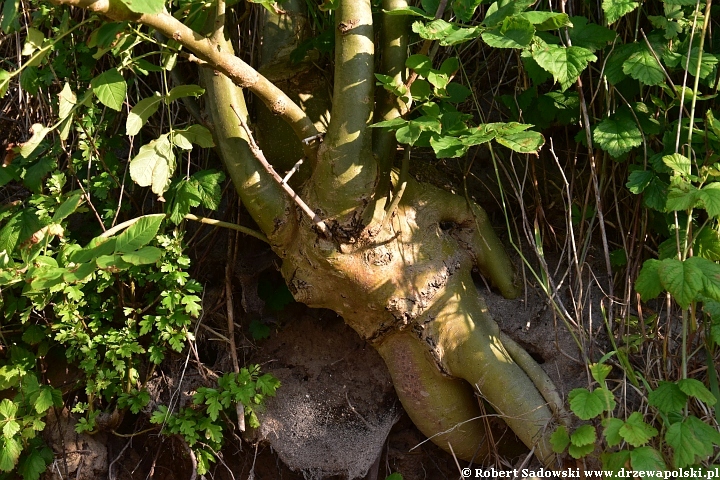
130 134 175 196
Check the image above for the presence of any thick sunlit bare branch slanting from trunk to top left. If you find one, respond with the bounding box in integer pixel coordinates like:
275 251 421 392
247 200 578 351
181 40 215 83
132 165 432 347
51 0 318 158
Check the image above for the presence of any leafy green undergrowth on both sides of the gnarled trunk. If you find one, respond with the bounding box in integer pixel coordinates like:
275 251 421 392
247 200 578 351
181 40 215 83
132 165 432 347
0 0 720 479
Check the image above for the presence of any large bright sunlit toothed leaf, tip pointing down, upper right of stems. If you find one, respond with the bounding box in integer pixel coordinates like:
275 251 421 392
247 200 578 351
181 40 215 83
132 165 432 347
532 42 597 90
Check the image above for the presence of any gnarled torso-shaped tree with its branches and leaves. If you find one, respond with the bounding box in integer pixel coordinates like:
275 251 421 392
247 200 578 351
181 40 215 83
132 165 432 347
0 0 572 472
